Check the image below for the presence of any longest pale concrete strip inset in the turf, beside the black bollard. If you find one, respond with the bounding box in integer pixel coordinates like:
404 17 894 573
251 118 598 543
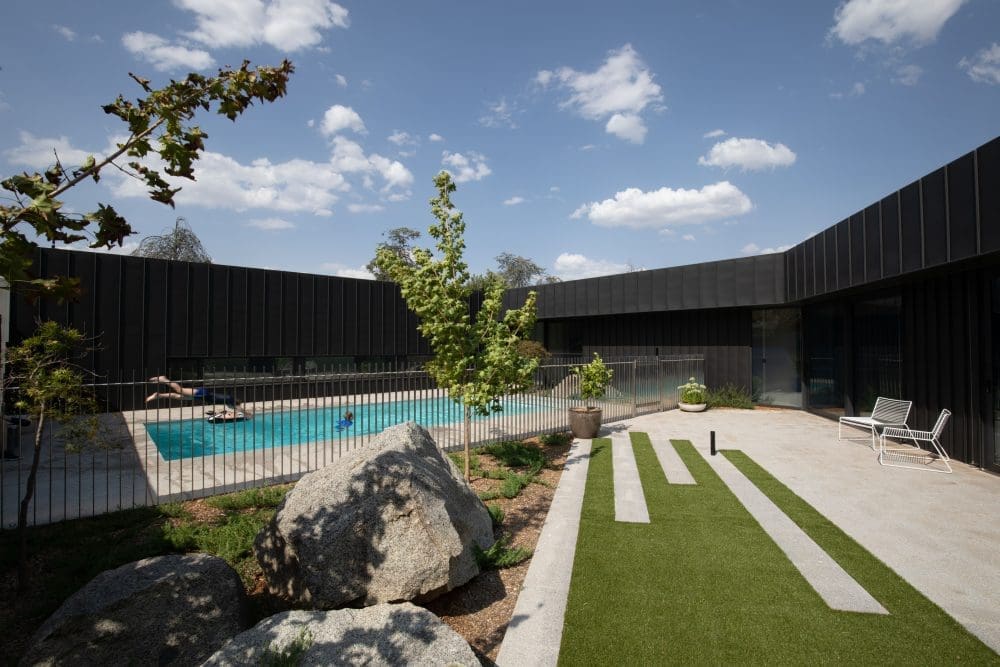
699 440 889 614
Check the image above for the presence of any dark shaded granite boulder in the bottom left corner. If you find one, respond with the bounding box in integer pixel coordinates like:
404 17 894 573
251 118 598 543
21 554 249 666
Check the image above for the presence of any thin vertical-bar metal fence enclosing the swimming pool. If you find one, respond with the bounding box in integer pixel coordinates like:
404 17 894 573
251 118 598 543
0 355 704 529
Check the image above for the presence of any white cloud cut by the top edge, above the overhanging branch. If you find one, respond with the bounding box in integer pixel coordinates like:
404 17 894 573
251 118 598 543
174 0 350 51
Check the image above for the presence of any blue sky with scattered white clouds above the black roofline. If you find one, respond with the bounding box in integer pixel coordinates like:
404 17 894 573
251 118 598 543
0 0 1000 279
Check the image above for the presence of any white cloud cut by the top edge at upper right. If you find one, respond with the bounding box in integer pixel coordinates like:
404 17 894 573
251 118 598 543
830 0 965 45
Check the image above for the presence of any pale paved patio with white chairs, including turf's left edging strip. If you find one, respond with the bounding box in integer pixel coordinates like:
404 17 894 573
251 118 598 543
498 409 1000 664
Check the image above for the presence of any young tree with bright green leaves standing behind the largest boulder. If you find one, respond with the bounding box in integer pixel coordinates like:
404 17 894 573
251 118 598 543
375 171 538 480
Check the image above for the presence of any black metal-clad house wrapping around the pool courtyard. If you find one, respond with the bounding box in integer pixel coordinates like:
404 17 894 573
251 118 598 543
11 138 1000 470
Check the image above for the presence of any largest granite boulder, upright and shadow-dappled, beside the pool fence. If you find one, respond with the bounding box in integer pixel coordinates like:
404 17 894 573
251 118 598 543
254 422 493 609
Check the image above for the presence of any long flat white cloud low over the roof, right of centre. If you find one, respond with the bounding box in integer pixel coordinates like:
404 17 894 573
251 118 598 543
571 181 753 229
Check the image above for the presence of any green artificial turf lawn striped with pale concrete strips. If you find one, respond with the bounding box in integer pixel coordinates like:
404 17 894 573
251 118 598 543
560 433 1000 665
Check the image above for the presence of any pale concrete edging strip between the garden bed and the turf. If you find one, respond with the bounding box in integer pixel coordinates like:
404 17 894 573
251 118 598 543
497 440 591 667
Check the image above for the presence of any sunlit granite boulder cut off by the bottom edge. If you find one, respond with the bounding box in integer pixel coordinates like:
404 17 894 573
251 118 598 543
204 602 479 667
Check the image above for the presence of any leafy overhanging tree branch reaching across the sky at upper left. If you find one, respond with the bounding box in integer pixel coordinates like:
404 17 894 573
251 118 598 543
0 60 294 298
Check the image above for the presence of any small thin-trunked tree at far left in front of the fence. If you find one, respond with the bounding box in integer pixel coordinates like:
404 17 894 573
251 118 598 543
6 322 97 590
